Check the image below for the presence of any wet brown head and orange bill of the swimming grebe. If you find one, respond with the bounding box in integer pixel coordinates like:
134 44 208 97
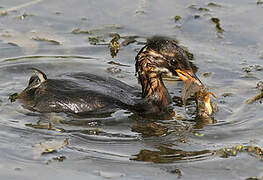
135 36 203 86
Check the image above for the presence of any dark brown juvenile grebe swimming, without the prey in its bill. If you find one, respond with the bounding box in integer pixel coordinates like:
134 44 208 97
18 37 202 114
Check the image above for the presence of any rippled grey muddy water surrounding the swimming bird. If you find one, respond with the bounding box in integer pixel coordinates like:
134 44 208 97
0 0 263 180
